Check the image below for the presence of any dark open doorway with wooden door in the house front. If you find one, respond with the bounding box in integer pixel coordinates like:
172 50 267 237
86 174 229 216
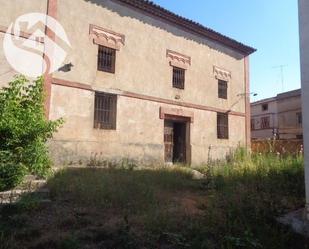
164 120 189 163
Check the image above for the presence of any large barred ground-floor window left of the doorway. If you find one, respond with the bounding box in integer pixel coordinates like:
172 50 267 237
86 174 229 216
94 92 117 130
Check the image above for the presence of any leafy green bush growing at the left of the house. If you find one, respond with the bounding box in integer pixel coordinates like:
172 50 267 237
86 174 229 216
0 76 62 191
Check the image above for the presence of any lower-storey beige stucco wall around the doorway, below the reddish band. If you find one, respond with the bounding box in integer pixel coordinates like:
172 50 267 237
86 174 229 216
50 85 245 164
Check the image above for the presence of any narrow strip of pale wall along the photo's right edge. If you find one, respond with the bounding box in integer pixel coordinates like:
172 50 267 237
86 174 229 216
298 0 309 220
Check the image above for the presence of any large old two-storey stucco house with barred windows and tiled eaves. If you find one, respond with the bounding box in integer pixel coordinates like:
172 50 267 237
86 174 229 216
0 0 255 164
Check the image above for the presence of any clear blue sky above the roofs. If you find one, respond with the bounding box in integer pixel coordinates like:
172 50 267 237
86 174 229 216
153 0 300 101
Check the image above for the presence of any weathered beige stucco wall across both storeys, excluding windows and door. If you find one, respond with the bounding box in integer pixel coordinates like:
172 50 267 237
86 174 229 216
0 0 248 164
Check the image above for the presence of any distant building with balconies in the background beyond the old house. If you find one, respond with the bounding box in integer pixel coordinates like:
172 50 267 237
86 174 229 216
251 89 303 139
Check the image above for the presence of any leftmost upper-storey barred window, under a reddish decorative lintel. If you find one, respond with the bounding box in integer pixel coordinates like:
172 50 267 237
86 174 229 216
98 46 116 73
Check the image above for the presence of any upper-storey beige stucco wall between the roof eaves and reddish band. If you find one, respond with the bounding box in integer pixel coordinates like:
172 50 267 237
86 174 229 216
54 0 245 112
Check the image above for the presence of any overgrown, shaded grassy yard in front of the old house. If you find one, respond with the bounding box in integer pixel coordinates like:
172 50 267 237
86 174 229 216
0 153 309 249
